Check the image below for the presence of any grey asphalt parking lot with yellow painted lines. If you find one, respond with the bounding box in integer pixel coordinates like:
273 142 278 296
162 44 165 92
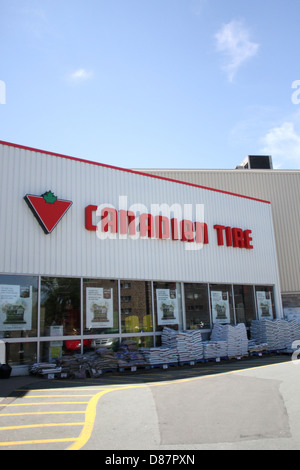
0 354 300 452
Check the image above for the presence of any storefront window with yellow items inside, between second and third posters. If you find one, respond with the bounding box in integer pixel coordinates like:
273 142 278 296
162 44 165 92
121 281 153 333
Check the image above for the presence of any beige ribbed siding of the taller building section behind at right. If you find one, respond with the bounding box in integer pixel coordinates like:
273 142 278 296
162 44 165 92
140 170 300 293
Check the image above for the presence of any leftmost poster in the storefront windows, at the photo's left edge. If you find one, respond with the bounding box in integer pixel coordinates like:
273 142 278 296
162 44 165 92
0 284 32 331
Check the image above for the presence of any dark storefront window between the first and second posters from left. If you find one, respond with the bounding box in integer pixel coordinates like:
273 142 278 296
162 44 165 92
41 277 80 336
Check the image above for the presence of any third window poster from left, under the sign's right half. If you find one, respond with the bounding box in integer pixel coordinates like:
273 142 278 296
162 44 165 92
156 289 179 325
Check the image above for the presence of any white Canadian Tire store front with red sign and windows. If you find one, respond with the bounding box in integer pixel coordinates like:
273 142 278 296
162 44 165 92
0 142 282 373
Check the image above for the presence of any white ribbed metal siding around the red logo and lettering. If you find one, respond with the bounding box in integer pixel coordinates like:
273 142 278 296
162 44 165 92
0 145 279 312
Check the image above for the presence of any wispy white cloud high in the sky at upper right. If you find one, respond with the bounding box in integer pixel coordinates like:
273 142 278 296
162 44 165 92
215 20 259 82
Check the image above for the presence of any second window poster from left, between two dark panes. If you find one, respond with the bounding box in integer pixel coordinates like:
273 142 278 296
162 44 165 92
86 287 113 328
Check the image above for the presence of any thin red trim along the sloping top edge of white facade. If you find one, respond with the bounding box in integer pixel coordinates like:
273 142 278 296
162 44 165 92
0 140 271 204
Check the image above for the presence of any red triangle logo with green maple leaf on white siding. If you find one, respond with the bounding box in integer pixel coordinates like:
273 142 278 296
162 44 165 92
24 191 73 235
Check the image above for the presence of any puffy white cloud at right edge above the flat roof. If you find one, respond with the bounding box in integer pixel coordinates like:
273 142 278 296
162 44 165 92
262 121 300 169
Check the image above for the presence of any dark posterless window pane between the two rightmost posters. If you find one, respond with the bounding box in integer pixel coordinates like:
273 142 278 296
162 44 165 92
233 286 256 327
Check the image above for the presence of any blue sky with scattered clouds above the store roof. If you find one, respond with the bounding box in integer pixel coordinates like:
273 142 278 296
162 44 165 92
0 0 300 169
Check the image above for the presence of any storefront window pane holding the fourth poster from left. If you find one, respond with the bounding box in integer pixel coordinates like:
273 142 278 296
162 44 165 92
210 284 234 324
